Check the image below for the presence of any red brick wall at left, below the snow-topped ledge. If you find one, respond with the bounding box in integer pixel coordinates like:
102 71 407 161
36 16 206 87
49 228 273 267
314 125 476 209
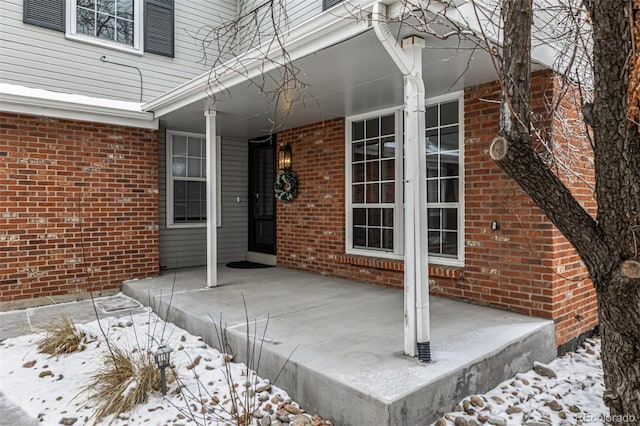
0 113 159 309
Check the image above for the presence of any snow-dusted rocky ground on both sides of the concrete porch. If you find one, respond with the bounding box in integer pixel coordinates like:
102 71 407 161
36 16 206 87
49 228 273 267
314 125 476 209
0 302 608 426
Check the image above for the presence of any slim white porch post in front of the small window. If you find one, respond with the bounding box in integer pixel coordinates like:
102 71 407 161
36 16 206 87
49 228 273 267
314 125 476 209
204 109 218 287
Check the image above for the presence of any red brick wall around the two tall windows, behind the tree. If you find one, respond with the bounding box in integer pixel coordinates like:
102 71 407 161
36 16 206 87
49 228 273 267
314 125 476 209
277 73 597 345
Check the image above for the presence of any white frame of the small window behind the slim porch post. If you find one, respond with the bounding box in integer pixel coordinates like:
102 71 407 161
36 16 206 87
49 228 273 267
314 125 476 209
166 130 222 229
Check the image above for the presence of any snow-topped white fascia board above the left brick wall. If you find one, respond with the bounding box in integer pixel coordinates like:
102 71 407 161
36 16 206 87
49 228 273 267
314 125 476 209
0 83 158 130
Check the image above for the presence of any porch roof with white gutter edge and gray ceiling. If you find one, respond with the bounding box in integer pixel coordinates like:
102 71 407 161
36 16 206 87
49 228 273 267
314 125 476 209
143 0 550 139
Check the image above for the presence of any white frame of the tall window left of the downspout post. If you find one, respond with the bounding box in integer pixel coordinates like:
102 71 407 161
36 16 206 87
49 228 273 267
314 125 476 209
345 106 404 260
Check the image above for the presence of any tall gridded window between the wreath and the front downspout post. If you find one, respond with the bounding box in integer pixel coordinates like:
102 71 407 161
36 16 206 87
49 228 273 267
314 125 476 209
347 111 402 255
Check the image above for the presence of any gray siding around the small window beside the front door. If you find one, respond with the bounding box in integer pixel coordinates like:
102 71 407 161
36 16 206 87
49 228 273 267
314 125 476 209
158 127 248 268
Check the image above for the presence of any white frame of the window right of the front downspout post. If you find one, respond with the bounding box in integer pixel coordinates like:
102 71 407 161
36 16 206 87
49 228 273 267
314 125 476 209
423 91 465 266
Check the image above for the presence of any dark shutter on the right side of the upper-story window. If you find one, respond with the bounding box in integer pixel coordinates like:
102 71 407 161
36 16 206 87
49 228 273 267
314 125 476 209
144 0 173 58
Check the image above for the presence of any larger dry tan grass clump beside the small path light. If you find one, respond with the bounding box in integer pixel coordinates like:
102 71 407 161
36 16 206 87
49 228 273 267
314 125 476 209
81 345 170 423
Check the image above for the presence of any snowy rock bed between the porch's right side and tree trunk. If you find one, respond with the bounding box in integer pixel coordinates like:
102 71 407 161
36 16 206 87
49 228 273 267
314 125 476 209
434 339 609 426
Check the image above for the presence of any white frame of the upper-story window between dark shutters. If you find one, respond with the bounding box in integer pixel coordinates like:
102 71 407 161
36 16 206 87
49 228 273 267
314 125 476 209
65 0 144 56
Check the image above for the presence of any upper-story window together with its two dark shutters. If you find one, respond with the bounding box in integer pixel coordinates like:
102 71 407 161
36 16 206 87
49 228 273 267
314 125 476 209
23 0 174 57
